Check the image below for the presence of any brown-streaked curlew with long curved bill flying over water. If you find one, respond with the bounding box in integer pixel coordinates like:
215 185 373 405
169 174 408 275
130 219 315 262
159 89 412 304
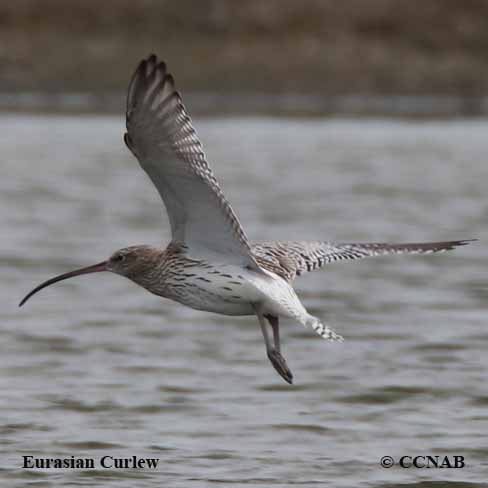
19 55 469 383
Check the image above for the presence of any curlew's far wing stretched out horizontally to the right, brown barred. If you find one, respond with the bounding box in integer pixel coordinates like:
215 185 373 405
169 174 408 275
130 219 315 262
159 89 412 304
252 239 475 281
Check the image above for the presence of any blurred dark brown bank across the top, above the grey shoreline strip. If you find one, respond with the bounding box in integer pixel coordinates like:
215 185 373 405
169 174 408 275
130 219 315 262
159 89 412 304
0 0 488 106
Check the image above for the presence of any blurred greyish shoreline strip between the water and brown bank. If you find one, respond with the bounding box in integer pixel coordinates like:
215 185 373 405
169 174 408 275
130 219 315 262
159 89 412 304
0 92 488 118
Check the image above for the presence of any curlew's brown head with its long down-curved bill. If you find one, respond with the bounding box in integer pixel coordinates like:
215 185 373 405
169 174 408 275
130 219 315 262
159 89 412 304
19 246 161 307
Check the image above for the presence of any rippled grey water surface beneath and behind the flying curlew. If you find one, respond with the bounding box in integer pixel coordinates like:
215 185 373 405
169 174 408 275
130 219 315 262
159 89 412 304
0 114 488 488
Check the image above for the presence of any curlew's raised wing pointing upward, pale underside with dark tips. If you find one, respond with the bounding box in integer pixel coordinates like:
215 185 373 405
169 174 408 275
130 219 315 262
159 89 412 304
124 55 257 267
